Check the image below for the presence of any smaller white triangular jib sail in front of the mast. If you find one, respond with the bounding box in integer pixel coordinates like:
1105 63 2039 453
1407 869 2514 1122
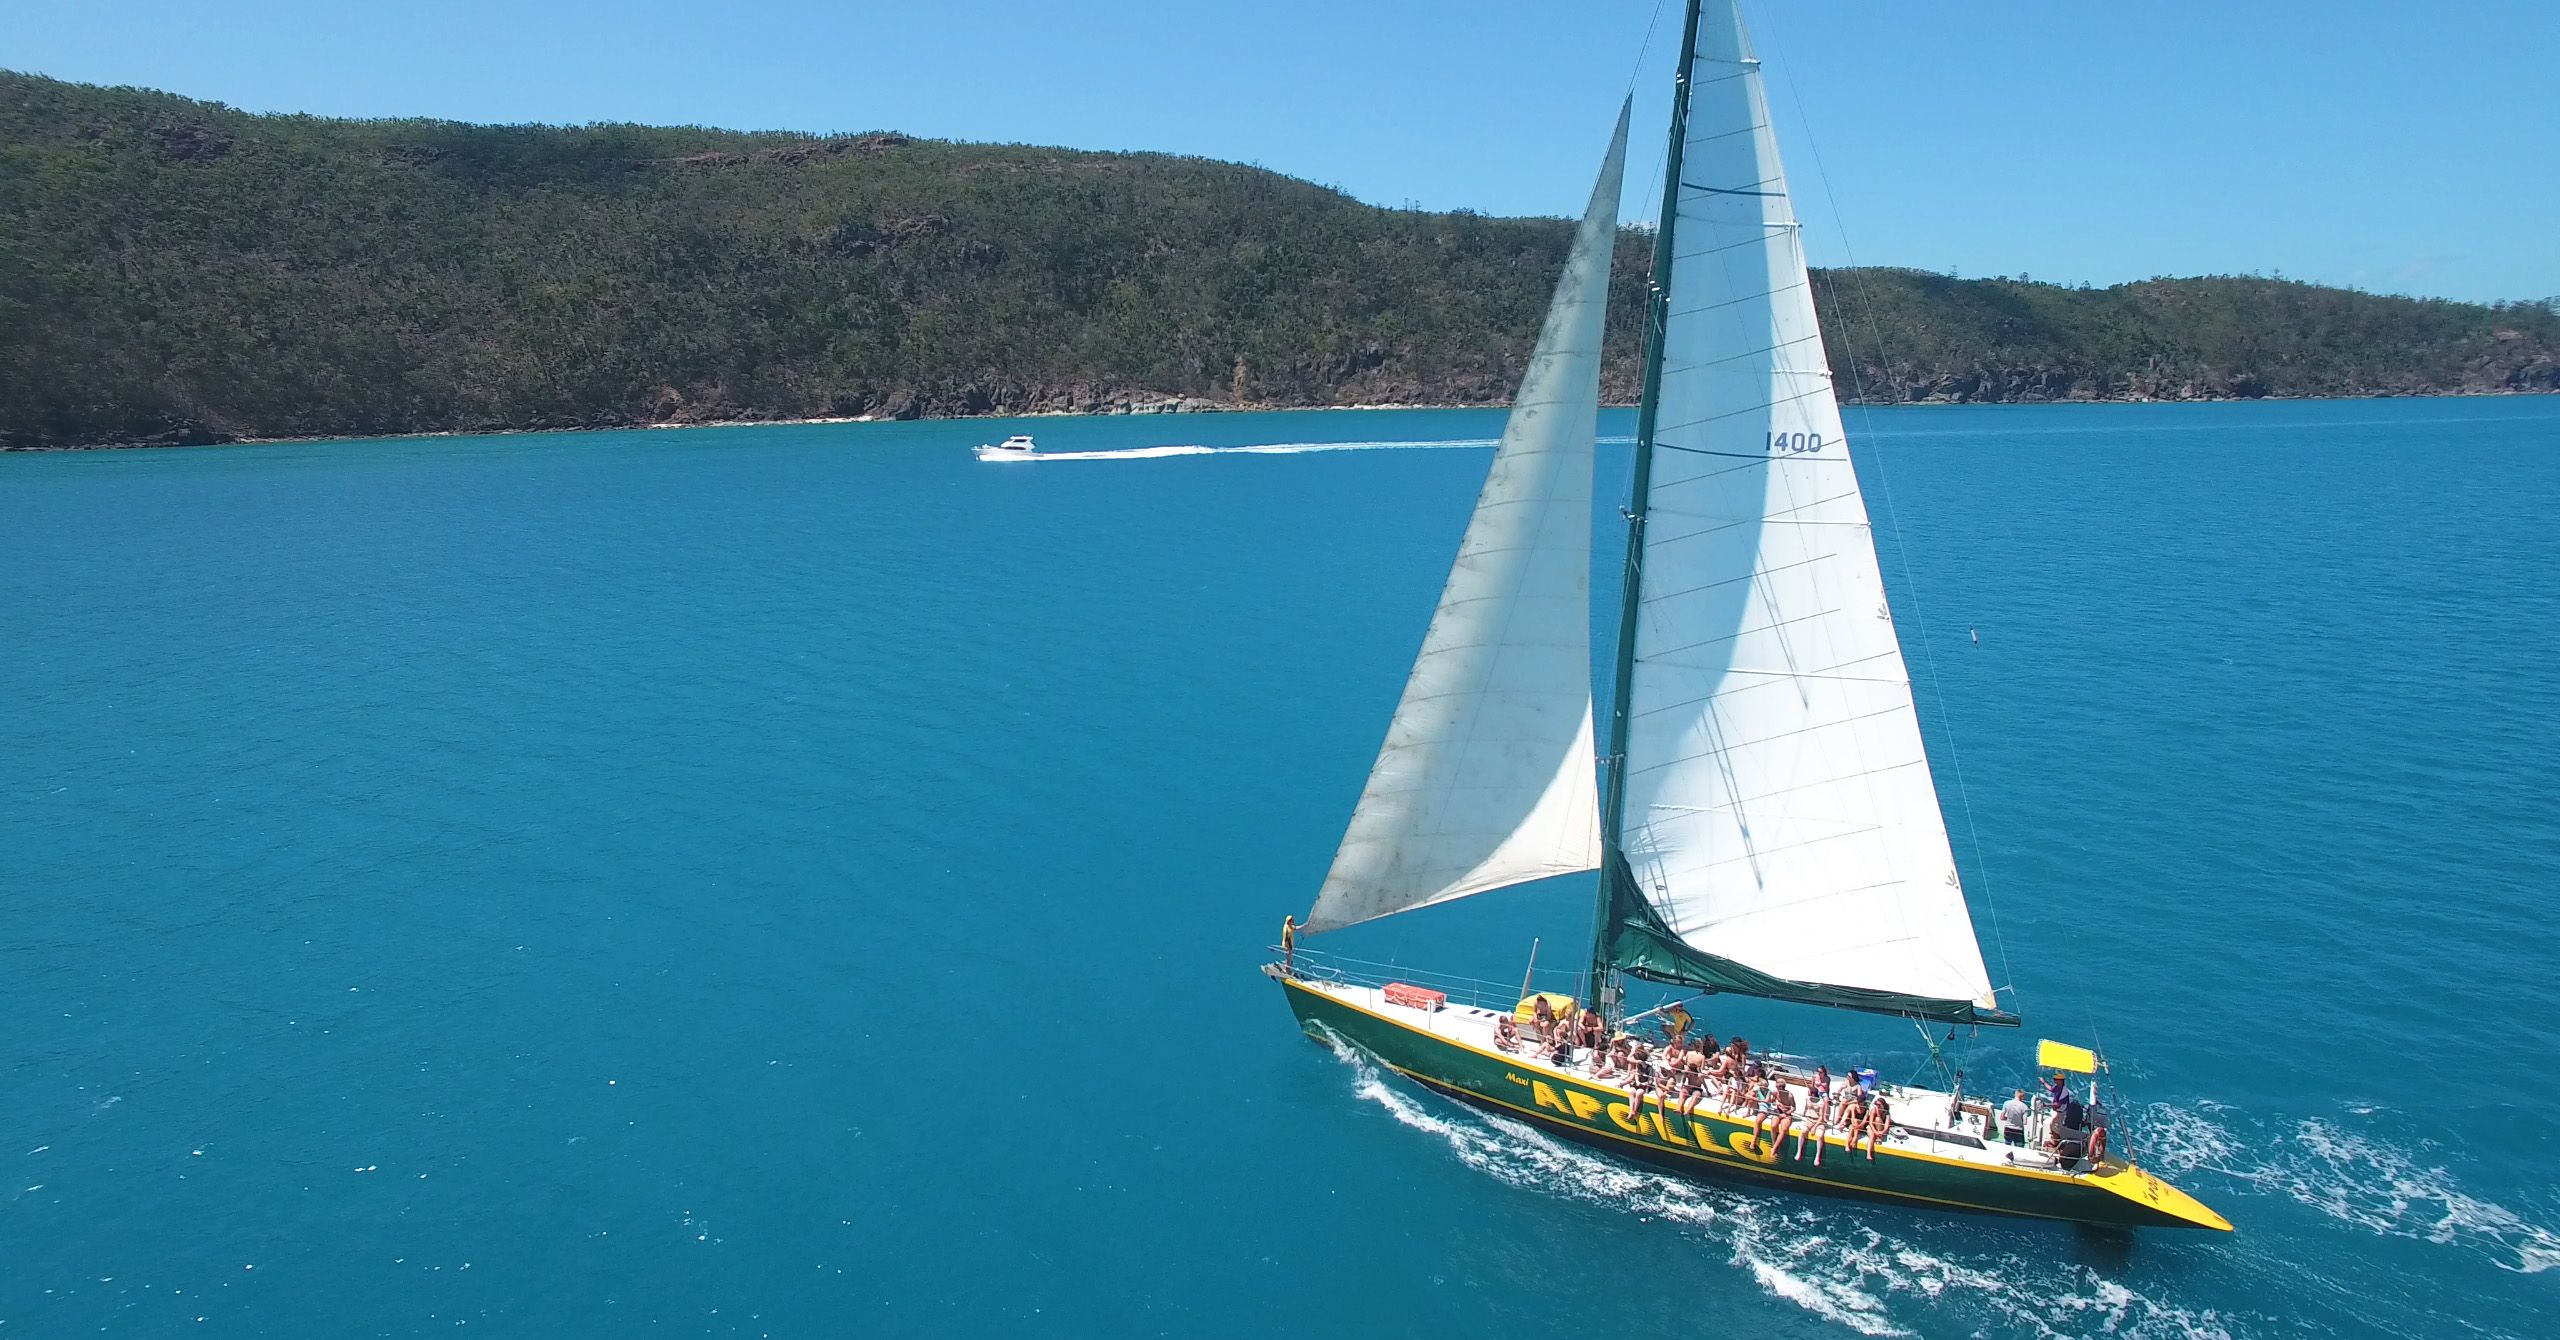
1306 110 1626 930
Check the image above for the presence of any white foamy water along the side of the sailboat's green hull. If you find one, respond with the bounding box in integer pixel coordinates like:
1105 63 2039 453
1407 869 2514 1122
1331 1043 2235 1340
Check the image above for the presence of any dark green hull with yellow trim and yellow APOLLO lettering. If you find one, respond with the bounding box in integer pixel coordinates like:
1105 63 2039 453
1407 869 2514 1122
1275 971 2232 1232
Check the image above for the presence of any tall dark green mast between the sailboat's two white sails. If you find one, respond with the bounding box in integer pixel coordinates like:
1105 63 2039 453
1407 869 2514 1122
1590 0 1697 1007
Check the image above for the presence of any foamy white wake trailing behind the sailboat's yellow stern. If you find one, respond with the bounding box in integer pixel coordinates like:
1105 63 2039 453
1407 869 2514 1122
2140 1102 2560 1273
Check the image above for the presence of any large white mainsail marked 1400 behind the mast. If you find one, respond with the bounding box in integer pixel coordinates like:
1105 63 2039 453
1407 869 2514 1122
1620 0 1994 1007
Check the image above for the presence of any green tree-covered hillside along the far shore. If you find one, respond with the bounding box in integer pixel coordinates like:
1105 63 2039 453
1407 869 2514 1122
0 72 2560 446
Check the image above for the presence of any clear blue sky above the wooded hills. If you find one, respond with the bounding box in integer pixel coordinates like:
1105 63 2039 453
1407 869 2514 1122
0 0 2560 300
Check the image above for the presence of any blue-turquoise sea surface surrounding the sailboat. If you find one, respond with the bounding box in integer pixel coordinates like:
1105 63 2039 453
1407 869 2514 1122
0 397 2560 1340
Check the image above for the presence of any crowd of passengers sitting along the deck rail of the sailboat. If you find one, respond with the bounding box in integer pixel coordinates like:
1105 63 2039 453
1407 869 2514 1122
1492 997 1894 1168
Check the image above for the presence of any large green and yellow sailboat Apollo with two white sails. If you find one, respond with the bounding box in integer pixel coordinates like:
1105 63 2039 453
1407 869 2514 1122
1265 0 2230 1232
